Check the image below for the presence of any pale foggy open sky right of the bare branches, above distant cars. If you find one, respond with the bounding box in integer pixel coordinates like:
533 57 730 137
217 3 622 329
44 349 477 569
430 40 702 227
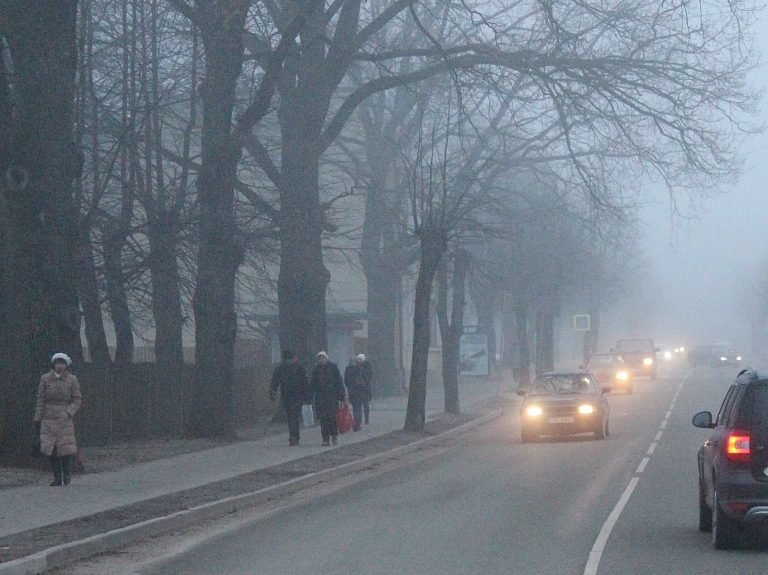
601 11 768 363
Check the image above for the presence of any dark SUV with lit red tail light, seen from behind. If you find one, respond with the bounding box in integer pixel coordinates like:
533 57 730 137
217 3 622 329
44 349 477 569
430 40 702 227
693 369 768 549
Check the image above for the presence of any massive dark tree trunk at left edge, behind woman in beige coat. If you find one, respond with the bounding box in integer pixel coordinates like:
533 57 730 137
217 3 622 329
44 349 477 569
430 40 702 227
0 0 82 460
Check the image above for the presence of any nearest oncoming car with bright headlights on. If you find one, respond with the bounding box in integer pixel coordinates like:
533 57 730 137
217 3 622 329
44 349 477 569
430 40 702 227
517 371 610 443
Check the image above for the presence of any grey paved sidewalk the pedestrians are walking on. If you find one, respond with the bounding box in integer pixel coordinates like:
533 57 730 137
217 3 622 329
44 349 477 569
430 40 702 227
0 379 511 548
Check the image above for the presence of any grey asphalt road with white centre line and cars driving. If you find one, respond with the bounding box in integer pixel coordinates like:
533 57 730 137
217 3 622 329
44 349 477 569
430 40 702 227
55 367 768 575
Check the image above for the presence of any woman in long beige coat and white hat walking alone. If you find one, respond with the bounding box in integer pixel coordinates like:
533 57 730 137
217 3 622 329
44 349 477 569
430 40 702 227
35 353 82 487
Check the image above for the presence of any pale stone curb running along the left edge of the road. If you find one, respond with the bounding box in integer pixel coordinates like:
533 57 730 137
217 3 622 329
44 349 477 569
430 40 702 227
0 410 504 575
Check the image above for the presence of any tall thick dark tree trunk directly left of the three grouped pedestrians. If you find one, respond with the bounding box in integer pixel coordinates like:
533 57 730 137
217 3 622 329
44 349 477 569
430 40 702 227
188 0 249 438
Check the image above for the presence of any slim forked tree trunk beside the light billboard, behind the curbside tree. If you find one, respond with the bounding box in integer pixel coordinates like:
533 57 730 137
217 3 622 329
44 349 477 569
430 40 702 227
437 252 469 414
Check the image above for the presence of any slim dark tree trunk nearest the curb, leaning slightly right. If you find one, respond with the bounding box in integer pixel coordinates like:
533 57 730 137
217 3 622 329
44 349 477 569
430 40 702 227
404 229 447 431
